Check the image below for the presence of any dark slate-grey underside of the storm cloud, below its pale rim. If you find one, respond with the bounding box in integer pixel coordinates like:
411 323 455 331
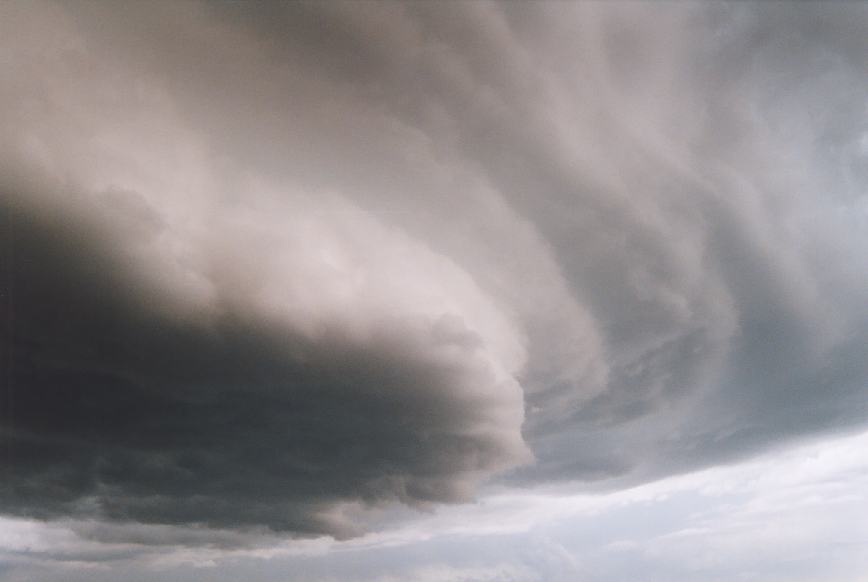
0 195 508 536
